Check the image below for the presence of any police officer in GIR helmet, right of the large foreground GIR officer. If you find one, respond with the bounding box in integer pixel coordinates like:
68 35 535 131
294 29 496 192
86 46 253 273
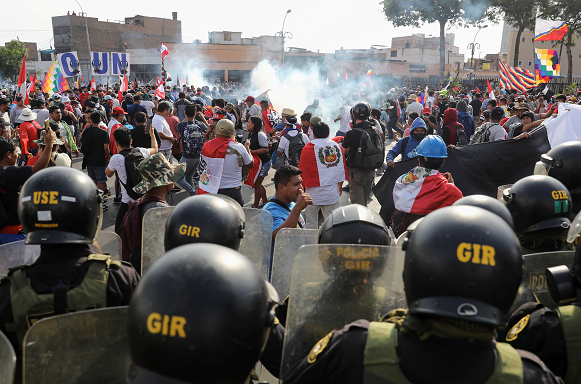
503 175 573 254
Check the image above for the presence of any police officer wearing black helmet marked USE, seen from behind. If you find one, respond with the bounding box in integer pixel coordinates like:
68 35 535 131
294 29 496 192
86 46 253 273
0 167 139 351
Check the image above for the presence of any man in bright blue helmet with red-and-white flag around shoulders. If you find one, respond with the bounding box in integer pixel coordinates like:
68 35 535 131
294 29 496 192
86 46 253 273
391 135 462 236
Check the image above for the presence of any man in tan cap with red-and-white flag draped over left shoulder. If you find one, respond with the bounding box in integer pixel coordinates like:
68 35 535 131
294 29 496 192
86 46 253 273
197 119 254 206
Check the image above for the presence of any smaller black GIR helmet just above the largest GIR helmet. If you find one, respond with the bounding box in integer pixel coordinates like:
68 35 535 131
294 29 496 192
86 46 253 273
164 194 245 251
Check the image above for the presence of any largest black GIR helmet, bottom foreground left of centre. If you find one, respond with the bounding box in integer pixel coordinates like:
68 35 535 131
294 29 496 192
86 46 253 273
127 243 278 384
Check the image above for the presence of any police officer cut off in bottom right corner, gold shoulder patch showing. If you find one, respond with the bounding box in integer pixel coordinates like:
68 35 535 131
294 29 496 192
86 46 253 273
506 243 581 384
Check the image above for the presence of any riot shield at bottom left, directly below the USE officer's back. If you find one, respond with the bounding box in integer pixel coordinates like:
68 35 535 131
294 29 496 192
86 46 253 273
23 307 131 384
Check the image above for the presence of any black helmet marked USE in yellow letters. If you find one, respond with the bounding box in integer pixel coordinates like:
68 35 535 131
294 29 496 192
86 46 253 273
18 167 103 244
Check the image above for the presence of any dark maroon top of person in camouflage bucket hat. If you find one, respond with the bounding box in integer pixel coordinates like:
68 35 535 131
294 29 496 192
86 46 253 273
118 196 167 273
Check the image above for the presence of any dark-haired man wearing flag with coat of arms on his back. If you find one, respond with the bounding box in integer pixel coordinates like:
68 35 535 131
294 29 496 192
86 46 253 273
299 122 349 229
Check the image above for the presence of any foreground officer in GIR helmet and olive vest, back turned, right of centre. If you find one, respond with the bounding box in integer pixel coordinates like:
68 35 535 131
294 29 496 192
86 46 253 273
285 206 558 384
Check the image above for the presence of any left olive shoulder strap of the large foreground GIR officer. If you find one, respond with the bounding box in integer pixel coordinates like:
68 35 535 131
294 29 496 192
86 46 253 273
363 322 410 384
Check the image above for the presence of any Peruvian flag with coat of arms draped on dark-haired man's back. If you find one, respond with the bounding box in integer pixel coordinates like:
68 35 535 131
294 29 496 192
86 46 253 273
299 139 349 188
